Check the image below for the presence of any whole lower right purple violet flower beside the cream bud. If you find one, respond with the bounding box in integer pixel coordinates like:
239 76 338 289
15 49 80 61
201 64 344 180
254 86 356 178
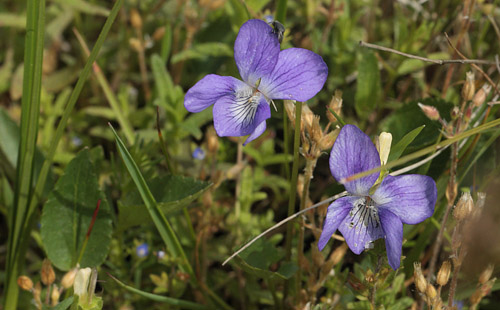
318 125 437 270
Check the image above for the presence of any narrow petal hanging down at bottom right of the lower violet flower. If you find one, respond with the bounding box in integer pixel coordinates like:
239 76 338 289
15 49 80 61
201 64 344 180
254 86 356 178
379 209 403 270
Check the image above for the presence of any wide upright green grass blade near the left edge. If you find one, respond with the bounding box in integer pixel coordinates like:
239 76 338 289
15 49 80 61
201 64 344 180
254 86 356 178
4 0 45 309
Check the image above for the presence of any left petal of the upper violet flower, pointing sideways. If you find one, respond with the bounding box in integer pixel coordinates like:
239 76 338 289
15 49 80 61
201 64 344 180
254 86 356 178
184 74 245 113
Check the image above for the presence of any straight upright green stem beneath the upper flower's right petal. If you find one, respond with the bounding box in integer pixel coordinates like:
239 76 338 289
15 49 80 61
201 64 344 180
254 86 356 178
284 101 302 298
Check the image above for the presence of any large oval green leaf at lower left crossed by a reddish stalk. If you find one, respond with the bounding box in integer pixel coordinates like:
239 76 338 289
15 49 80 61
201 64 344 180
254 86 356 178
41 149 112 270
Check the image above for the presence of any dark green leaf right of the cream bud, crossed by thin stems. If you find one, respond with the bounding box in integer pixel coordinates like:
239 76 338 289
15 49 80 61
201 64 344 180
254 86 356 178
380 98 453 151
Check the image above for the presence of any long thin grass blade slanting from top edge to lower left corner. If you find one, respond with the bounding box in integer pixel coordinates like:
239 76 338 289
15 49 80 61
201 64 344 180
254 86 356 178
4 0 123 309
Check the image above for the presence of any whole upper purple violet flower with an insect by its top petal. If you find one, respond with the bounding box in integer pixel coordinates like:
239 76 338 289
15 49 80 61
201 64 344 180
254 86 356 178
184 19 328 144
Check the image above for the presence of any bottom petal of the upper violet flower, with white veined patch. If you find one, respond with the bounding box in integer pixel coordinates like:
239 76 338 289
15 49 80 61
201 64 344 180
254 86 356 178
213 90 271 137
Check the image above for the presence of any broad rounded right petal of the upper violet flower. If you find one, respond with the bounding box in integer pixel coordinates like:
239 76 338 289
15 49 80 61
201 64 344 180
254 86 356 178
259 48 328 101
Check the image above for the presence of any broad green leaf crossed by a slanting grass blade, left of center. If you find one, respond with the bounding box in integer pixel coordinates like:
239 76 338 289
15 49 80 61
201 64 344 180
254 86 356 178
118 175 212 230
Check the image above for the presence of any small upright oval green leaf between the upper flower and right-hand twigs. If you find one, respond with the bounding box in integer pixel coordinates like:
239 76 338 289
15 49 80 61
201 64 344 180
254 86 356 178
355 50 380 119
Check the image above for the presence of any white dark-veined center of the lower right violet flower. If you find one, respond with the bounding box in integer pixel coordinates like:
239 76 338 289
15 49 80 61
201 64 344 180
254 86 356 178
349 197 380 230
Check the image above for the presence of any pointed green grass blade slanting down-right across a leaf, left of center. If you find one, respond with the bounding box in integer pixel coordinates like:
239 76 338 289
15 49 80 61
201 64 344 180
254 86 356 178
110 125 195 279
